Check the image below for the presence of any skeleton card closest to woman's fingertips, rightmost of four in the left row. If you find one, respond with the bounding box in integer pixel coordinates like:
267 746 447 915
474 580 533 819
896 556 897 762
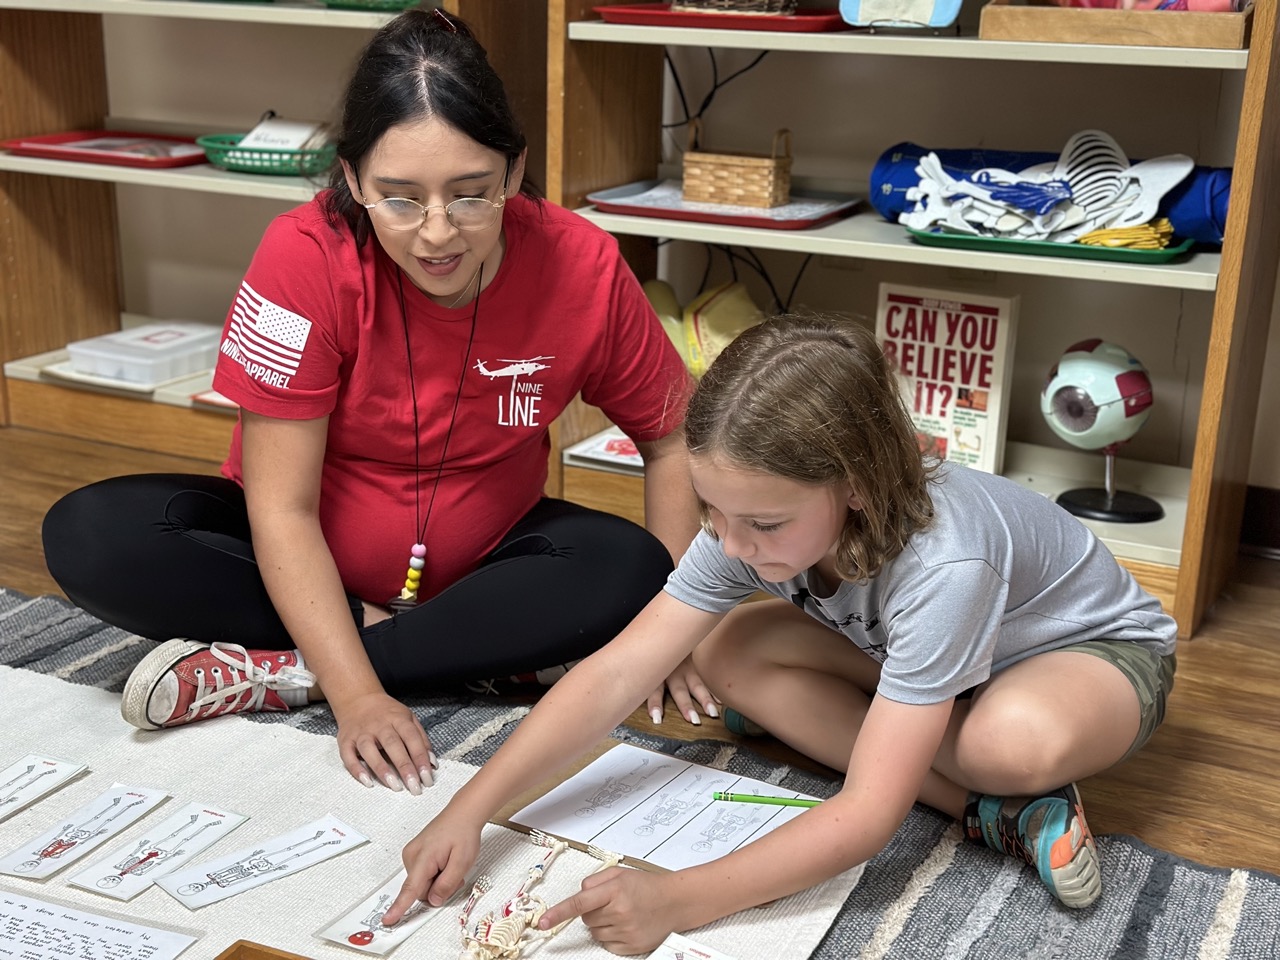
156 814 369 910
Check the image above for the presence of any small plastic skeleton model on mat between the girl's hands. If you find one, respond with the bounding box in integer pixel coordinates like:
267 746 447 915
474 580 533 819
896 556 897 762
458 831 622 960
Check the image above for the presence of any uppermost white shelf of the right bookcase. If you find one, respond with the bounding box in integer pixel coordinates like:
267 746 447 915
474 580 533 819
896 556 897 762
568 20 1249 70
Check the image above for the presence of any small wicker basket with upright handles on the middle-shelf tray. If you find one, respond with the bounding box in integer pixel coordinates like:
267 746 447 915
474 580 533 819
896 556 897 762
681 122 791 207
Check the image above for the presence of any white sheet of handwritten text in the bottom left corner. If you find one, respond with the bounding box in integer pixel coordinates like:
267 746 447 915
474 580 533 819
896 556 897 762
0 888 198 960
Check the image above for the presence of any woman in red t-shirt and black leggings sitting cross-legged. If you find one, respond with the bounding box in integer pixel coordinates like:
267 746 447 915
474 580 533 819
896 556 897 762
44 10 714 794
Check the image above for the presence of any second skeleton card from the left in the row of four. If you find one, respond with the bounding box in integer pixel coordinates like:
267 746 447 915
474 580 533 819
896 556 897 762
0 783 169 879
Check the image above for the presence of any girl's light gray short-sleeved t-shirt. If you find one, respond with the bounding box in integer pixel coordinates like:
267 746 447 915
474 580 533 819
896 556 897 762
666 463 1178 704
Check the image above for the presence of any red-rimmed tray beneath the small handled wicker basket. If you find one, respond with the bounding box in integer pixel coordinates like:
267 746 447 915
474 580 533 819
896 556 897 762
586 180 861 230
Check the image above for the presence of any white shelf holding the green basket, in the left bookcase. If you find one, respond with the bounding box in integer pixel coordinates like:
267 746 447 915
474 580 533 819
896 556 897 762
0 152 324 204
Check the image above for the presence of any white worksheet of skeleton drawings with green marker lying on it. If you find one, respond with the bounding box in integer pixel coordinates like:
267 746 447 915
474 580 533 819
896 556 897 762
511 744 814 870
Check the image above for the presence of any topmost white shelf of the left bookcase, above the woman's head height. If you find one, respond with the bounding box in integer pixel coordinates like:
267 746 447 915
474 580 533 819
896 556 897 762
0 0 407 28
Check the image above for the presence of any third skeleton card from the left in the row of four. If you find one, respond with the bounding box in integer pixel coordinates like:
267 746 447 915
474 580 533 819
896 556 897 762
68 803 248 900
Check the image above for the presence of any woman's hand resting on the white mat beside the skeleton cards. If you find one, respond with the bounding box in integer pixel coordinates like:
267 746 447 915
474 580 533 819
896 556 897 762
332 691 435 796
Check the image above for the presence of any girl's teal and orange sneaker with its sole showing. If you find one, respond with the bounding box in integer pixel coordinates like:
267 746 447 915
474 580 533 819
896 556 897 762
964 783 1102 909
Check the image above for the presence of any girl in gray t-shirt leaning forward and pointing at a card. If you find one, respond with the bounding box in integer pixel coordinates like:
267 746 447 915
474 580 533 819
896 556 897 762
387 317 1176 954
